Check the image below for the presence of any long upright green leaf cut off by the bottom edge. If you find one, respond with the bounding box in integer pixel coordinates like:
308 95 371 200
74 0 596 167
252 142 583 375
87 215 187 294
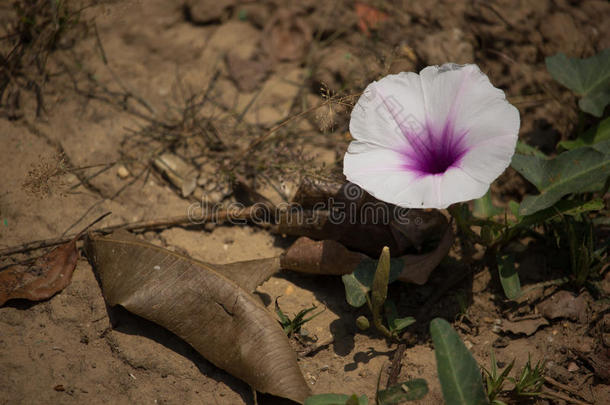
430 318 489 405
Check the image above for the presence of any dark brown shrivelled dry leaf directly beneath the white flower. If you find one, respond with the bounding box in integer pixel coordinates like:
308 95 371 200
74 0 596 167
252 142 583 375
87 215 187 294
272 179 450 257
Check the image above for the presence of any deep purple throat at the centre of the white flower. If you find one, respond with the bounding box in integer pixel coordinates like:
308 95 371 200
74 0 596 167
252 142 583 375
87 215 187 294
401 120 467 175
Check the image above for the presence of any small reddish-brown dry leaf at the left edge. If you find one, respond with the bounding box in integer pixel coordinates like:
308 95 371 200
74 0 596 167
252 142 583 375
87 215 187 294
0 239 78 305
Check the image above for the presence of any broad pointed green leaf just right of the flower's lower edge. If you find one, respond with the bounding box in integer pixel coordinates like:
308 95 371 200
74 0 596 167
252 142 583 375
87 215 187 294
511 142 610 215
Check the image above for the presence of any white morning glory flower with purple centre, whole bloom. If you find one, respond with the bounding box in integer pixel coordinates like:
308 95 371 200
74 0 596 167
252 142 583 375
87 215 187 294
343 64 520 208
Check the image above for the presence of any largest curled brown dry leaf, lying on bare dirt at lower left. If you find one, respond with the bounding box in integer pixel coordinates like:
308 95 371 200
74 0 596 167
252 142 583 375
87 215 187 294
85 233 309 403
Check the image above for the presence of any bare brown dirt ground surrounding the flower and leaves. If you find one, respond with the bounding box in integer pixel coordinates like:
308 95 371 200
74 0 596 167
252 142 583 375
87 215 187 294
0 0 610 405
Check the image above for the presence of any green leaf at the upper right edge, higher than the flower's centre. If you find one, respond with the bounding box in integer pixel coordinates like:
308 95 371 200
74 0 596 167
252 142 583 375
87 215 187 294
546 48 610 117
